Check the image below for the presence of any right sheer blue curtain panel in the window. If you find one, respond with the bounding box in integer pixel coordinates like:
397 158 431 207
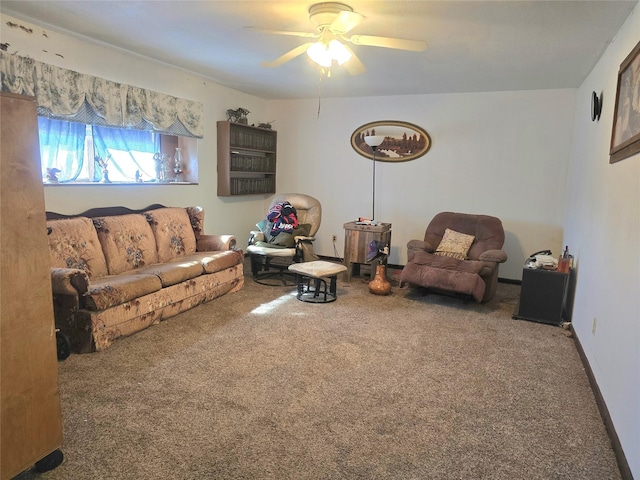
93 125 160 181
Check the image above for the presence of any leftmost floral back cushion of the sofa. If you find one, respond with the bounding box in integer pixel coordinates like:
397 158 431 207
47 217 108 278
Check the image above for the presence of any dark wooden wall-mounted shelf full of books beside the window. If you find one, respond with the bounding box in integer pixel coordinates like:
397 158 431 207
218 122 278 197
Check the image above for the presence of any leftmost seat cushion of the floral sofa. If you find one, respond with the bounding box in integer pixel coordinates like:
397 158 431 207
83 274 162 310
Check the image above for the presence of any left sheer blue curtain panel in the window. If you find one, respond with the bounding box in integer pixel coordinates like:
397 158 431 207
38 117 86 182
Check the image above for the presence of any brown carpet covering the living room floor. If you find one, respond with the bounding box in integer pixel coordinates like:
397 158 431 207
17 269 620 480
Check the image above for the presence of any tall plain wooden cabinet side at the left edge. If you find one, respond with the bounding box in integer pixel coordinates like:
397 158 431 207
0 93 62 480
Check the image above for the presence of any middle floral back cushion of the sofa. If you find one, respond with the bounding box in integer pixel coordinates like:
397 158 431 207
93 213 158 275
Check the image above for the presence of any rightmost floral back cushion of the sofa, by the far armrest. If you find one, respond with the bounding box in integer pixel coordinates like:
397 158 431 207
144 207 196 263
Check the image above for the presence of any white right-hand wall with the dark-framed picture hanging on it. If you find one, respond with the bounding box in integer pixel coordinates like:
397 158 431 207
564 6 640 478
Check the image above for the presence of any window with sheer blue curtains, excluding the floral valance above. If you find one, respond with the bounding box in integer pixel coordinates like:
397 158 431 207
38 117 197 184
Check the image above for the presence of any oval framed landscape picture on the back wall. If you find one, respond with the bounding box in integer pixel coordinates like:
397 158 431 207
351 120 431 162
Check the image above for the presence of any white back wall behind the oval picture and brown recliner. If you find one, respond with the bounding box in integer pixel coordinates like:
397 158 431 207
269 89 575 279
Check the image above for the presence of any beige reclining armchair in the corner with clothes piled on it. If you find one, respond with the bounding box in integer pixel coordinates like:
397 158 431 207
246 193 322 285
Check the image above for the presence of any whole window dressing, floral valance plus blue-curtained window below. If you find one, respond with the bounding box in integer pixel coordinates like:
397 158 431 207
0 50 204 185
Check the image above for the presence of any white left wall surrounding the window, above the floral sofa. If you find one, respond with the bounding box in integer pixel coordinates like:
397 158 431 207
0 15 268 245
